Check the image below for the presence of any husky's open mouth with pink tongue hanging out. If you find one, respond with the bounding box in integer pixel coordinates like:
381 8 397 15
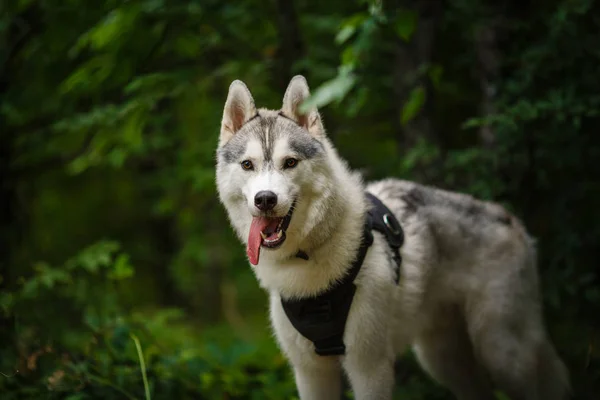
246 200 296 265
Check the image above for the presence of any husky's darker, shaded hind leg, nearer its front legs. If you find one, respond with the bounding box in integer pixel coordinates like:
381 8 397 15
414 309 494 400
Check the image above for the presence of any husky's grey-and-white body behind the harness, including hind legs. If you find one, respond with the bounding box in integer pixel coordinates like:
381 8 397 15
367 179 569 399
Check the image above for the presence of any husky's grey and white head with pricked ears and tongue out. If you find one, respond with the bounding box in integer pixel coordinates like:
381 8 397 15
217 76 332 265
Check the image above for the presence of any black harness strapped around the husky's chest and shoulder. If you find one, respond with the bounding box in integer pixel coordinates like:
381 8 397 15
281 193 404 356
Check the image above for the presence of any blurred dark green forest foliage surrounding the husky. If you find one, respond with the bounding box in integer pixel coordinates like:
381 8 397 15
0 0 600 400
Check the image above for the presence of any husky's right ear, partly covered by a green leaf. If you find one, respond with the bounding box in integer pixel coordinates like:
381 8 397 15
281 75 325 137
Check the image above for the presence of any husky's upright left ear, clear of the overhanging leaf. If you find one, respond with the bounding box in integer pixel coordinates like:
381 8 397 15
219 80 256 145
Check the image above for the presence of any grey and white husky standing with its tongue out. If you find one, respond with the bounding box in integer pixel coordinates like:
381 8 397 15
216 76 570 400
